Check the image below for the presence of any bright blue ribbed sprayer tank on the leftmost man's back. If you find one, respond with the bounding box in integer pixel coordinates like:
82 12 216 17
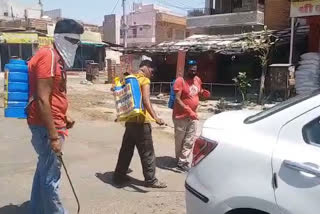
4 59 29 119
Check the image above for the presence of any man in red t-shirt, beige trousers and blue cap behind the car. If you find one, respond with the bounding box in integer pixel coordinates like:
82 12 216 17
173 60 210 171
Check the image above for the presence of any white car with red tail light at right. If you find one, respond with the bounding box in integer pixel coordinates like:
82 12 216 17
185 91 320 214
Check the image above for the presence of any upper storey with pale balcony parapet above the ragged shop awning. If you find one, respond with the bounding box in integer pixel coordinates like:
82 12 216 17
187 0 290 35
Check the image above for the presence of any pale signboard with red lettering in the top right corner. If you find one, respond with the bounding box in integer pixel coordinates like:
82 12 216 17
290 0 320 17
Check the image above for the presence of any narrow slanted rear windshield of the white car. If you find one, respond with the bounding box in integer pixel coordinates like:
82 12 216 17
244 90 320 124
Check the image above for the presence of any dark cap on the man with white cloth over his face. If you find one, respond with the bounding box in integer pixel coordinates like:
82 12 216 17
54 19 84 34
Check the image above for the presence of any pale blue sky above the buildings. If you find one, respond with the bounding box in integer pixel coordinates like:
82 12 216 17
21 0 205 25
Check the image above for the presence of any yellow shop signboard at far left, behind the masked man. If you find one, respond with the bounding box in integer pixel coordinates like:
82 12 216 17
2 33 38 44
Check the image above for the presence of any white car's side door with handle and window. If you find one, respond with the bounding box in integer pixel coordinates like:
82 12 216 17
272 107 320 214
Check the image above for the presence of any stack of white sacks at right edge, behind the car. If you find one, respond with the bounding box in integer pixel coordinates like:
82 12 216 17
296 53 320 94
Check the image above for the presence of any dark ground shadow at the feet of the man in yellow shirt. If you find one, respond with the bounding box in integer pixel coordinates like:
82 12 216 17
95 172 149 193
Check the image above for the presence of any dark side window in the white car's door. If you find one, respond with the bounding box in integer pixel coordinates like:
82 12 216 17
302 117 320 146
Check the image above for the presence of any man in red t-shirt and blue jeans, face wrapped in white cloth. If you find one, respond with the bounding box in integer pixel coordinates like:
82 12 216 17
28 19 84 214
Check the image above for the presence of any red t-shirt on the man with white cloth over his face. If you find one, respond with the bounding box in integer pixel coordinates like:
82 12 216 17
28 47 68 128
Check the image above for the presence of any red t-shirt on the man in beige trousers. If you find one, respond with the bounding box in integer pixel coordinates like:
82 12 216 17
173 77 202 119
